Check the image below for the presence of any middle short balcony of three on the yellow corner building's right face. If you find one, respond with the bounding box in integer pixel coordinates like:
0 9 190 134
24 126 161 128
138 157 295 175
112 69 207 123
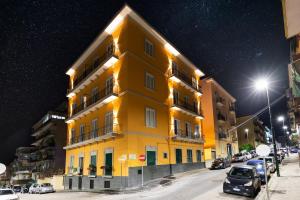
171 99 203 119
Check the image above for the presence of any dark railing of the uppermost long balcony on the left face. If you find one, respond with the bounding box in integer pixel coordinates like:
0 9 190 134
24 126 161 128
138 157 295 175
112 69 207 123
73 47 115 88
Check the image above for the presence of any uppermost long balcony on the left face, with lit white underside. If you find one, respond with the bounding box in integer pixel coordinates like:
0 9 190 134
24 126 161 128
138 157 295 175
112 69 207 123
67 48 118 97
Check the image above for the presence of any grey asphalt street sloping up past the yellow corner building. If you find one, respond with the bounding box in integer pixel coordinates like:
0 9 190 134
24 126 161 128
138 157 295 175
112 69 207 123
20 163 254 200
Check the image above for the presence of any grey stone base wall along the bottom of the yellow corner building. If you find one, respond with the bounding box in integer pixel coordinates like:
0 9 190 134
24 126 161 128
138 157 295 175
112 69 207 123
64 162 205 191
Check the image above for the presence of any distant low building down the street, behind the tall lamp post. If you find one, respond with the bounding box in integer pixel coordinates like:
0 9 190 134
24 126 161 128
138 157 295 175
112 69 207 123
237 115 266 148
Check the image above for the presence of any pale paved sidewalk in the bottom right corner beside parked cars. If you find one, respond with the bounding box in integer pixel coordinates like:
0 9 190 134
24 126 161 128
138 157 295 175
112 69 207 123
256 154 300 200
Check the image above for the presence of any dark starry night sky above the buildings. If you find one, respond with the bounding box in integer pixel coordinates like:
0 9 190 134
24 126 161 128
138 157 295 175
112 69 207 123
0 0 289 163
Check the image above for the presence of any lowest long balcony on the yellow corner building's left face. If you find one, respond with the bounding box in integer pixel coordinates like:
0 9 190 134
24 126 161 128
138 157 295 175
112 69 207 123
64 124 120 149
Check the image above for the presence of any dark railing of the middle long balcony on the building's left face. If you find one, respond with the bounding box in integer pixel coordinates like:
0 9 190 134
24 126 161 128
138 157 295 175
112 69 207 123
72 84 118 116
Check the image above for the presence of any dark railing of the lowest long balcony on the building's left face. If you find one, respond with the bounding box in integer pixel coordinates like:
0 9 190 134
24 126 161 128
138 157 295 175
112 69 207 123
69 124 118 145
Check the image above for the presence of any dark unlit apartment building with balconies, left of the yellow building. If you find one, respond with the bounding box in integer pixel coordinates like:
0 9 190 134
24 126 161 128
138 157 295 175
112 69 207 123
12 107 67 184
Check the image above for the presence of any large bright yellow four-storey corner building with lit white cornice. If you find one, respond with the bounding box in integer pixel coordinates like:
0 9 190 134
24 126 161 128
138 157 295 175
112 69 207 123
64 6 205 190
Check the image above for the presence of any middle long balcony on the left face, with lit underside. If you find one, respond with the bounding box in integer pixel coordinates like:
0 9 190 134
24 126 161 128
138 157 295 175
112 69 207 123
66 84 118 123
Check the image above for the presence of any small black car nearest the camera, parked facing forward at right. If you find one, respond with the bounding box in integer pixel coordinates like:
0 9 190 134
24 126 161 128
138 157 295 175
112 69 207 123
223 165 261 198
